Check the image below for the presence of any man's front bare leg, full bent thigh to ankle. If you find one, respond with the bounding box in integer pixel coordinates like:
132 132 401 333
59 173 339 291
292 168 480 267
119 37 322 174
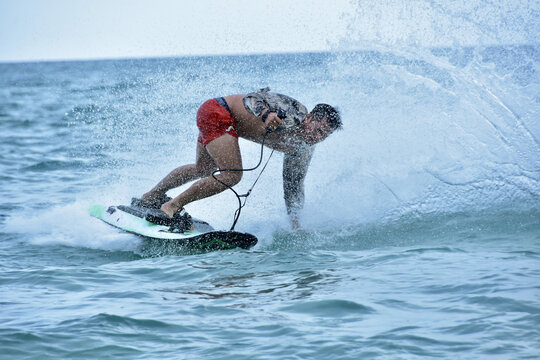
161 134 242 217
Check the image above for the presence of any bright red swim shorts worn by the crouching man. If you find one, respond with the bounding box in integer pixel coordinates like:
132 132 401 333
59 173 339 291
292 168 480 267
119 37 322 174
197 99 238 146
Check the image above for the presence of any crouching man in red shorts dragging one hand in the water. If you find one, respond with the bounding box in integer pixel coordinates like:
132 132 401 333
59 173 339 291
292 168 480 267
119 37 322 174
140 88 342 229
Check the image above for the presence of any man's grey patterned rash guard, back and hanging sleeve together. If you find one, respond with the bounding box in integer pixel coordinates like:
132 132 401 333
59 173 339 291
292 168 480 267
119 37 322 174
243 87 315 218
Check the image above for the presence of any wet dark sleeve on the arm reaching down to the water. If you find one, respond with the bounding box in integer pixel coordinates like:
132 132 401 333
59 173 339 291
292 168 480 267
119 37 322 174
283 146 314 218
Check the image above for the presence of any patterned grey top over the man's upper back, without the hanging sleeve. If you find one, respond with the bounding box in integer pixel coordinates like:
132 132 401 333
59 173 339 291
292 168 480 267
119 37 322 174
243 87 308 130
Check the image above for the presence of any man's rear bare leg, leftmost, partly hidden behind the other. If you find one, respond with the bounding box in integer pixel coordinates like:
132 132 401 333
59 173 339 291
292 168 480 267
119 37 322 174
142 142 216 202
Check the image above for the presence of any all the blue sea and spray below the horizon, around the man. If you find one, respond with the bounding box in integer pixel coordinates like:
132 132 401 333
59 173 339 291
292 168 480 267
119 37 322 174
0 44 540 359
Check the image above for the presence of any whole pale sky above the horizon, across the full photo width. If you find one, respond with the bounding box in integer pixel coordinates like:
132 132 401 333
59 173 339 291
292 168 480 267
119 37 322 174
0 0 540 62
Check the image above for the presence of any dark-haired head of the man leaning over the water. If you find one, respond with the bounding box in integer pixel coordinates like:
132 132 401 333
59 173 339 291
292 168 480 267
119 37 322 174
303 104 343 145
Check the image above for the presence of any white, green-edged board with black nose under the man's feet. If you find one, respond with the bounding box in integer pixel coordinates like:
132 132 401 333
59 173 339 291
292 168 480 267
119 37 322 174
89 205 257 251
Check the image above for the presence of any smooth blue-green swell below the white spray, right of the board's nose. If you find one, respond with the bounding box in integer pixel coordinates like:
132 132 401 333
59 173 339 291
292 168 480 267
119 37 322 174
266 209 540 253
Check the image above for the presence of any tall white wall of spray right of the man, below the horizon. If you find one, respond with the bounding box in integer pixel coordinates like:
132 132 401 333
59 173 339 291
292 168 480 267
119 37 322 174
298 46 540 228
